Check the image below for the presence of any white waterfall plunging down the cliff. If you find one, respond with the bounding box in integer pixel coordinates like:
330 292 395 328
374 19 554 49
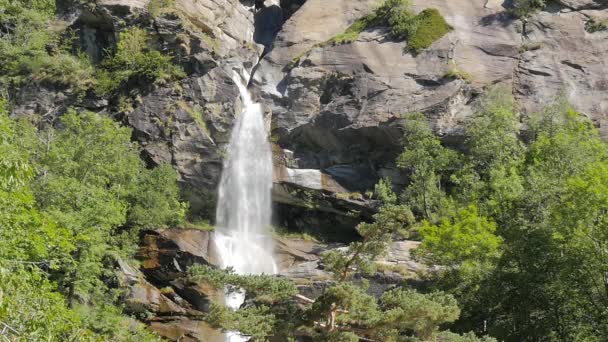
214 73 277 342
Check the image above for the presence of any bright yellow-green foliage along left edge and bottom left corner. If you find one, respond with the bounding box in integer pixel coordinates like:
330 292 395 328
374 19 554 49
0 101 163 341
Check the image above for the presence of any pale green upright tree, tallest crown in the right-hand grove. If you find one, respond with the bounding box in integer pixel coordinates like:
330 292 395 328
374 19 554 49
451 85 525 219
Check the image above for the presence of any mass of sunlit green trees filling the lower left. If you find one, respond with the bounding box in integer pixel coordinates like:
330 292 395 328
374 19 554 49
0 102 185 341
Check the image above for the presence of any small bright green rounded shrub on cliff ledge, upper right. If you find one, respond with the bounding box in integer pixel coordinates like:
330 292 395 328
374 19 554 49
408 8 453 53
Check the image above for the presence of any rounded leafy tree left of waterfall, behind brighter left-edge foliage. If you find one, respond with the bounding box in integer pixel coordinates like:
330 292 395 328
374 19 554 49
35 111 184 305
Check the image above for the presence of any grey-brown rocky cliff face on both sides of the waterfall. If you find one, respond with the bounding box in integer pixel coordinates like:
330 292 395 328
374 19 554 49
14 0 608 232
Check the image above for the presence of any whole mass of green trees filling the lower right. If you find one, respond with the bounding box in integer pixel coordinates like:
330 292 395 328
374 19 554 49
377 86 608 341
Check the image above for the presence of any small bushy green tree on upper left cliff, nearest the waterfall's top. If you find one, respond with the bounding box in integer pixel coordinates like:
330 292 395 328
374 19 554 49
97 27 185 94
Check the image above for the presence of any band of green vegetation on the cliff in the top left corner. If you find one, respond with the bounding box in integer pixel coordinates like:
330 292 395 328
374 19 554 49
0 0 185 97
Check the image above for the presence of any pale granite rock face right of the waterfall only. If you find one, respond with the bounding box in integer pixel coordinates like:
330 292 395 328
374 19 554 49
254 0 608 227
